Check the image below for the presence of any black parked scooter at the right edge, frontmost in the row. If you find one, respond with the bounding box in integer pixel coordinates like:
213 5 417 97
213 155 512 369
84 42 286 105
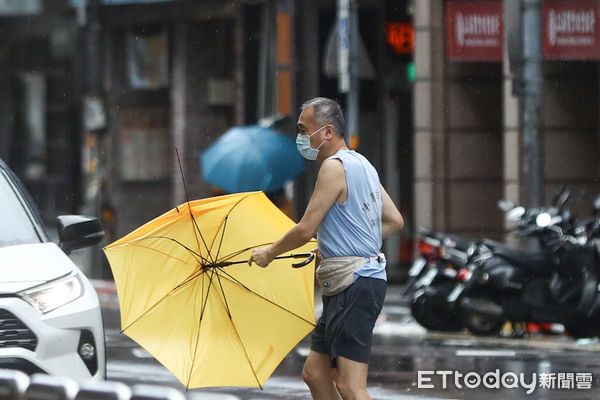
454 196 600 337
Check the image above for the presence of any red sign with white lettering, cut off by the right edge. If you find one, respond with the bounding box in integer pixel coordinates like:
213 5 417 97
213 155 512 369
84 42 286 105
543 0 600 60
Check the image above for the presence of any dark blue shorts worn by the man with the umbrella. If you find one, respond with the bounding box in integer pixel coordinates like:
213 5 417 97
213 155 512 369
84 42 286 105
311 277 387 368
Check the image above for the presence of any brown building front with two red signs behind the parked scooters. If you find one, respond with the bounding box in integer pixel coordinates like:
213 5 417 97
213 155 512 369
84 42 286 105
413 0 600 247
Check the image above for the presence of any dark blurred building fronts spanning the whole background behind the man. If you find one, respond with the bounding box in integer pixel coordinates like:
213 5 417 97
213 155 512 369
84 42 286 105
0 0 600 275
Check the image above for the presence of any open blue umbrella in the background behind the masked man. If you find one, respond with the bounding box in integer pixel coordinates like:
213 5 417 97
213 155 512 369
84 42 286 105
200 126 304 193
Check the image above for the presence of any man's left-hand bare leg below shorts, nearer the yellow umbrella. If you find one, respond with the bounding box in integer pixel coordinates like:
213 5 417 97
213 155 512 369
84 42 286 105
302 350 340 400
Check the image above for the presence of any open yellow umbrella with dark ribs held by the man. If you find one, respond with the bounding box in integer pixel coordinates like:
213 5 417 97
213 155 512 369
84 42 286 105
104 192 315 388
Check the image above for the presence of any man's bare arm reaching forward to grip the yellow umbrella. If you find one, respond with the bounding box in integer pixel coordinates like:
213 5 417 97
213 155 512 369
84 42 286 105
248 159 346 266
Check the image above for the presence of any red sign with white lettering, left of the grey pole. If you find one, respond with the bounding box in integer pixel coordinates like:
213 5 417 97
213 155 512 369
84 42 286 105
446 0 504 61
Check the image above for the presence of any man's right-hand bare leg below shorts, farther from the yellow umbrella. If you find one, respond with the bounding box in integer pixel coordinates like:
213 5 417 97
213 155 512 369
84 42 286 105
335 356 371 400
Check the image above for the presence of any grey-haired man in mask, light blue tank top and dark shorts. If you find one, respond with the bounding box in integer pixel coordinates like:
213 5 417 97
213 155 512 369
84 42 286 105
248 97 404 400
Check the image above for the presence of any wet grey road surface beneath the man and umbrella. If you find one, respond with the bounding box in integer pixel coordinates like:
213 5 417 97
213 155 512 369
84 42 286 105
101 287 600 400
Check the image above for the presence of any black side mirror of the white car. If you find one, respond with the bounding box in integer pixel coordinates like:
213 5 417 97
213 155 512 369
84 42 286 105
56 215 104 254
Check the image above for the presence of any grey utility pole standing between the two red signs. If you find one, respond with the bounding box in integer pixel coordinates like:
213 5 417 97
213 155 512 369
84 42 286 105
519 0 543 208
